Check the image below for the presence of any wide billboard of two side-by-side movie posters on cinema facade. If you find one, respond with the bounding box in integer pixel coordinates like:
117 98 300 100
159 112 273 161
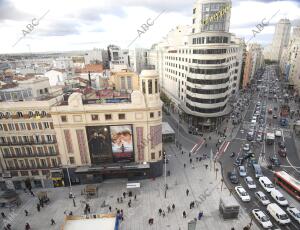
86 125 134 165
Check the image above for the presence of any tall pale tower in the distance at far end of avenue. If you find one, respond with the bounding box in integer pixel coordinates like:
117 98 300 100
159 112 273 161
264 19 291 61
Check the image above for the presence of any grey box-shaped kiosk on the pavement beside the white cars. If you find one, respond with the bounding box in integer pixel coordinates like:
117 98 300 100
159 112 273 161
219 196 240 219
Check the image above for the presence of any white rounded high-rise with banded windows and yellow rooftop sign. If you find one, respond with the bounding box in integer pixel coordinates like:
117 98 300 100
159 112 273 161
149 0 243 131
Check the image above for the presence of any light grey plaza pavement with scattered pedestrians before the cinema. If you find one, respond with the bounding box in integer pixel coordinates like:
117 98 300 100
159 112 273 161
0 145 258 230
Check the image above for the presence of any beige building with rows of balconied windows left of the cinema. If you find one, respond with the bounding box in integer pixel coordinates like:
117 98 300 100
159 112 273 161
0 77 63 189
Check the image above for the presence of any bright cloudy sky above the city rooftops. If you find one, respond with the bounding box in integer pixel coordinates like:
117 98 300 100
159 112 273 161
0 0 300 54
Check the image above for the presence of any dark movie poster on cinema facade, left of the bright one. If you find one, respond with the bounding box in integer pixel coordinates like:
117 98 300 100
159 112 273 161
86 126 113 165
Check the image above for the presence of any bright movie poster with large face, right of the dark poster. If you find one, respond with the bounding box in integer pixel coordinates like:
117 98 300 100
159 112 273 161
110 125 134 162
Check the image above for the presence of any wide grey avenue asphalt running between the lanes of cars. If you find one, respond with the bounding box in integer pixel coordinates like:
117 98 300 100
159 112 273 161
219 64 300 229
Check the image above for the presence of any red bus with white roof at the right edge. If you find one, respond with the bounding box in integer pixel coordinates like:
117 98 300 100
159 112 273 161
274 171 300 201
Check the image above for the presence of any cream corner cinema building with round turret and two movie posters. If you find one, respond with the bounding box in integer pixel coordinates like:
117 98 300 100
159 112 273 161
51 70 162 185
